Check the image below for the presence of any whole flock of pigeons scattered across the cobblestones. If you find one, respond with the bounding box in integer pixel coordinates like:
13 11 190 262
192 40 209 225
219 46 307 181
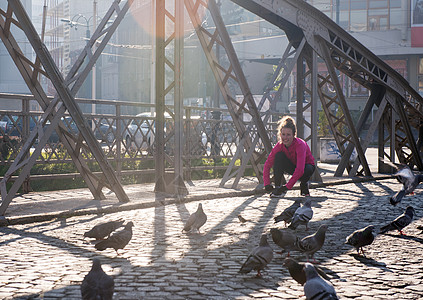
81 162 423 299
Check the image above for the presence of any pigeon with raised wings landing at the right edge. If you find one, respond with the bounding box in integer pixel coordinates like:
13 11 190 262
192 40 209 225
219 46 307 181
382 160 423 206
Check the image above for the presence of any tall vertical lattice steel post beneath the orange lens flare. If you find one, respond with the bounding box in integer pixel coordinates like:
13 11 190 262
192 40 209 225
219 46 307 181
154 0 188 196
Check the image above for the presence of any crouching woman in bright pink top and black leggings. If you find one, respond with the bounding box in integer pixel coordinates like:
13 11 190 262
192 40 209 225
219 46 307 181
263 116 316 197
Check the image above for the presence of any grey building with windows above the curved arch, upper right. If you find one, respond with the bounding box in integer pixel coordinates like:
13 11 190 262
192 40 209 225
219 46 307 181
308 0 423 98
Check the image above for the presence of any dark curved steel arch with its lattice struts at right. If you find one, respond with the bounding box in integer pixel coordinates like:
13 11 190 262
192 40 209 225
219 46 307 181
232 0 423 176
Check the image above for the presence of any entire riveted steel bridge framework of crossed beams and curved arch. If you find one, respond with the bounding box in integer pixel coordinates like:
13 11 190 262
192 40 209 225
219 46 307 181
0 0 423 215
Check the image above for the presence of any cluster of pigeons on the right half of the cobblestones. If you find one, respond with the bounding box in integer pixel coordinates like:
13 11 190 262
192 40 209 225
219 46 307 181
238 161 423 299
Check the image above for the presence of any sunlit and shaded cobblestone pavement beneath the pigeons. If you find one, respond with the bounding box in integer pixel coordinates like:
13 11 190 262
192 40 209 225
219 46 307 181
0 179 423 299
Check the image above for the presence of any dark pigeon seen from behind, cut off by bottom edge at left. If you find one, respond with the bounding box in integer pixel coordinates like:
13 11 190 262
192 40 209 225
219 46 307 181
81 258 115 300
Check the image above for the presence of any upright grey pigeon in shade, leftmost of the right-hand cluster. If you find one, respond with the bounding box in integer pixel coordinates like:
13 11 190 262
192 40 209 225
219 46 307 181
239 234 273 277
